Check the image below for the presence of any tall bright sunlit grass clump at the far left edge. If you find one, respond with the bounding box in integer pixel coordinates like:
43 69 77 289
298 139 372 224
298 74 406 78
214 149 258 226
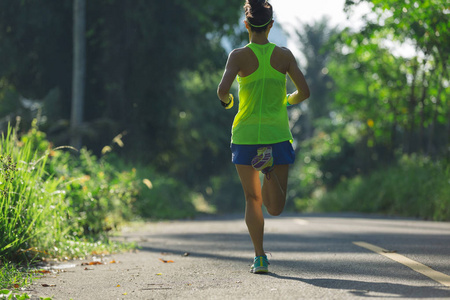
0 129 67 259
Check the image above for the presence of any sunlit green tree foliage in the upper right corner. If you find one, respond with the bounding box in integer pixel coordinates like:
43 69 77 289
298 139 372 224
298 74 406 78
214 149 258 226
342 0 450 156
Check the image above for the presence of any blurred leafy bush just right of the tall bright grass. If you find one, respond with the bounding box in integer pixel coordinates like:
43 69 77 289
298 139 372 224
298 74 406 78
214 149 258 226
48 148 138 238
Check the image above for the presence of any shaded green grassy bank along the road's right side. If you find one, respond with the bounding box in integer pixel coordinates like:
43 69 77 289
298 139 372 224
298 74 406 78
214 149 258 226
310 156 450 221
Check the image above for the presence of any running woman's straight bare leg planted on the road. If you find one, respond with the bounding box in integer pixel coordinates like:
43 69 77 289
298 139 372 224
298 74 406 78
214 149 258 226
236 165 265 256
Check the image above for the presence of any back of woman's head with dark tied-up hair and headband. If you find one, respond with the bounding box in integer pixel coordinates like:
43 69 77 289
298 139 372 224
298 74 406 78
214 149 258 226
244 0 273 32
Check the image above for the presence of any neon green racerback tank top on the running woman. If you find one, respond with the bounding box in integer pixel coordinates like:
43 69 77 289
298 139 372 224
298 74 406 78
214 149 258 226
231 43 292 145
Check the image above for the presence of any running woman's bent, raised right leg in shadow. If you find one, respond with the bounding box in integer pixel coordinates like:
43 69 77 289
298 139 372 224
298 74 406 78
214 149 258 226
262 165 289 216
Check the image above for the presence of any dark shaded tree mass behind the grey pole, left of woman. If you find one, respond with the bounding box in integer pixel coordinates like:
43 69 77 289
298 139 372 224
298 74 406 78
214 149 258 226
0 0 246 161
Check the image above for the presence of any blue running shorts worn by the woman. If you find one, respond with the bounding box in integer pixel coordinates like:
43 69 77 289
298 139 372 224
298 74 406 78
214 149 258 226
231 141 295 165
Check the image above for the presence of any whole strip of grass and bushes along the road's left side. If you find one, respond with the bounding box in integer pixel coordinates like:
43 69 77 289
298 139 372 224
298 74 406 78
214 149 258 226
0 120 195 289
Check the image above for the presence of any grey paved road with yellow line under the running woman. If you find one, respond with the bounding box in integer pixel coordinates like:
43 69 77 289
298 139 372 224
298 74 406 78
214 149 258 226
29 215 450 299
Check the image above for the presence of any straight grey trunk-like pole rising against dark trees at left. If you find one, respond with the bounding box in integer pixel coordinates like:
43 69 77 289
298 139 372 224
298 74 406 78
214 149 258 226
70 0 86 149
